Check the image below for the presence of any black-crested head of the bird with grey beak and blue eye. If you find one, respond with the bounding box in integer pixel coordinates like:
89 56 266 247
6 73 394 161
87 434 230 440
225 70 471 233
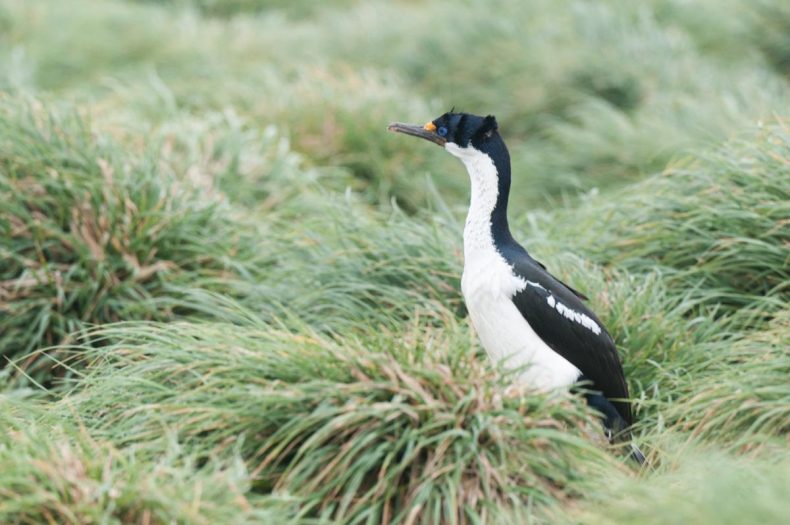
387 112 501 158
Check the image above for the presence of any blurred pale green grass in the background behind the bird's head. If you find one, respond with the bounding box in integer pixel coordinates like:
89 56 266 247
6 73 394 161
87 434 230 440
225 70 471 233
0 0 790 210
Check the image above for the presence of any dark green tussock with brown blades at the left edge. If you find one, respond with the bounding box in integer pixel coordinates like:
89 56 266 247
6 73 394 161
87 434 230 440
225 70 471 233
0 101 262 376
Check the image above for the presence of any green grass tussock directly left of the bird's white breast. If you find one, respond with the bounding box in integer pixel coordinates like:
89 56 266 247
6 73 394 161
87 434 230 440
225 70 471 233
234 194 464 331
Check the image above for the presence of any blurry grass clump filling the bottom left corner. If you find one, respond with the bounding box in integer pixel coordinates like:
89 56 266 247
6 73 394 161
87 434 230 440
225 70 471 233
0 398 285 525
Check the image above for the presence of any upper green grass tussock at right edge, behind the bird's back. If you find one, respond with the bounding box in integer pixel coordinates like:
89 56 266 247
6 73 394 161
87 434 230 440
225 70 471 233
557 125 790 320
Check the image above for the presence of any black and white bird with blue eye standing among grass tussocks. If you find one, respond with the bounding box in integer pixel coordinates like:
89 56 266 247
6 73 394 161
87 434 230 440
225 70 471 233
388 112 644 463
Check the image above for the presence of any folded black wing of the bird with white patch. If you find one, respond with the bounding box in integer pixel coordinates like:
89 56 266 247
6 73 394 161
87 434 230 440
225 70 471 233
508 254 632 425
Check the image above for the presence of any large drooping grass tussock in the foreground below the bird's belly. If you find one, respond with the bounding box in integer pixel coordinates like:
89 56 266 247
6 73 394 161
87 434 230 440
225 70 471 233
61 323 616 522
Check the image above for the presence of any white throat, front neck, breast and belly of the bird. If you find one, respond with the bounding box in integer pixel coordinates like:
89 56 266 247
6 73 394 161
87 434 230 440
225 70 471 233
452 143 579 389
